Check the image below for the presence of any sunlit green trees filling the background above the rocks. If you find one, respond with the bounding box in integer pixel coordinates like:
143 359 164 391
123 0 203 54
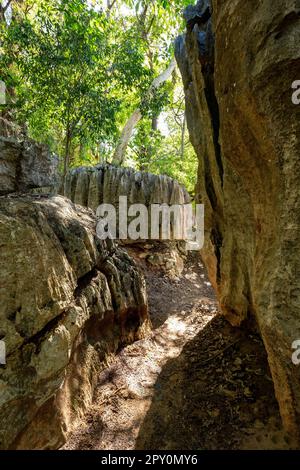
0 0 196 189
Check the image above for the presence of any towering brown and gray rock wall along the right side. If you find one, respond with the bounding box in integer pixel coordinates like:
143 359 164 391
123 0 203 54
176 0 300 437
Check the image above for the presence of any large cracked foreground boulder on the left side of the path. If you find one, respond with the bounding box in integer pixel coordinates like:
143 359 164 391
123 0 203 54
0 196 148 449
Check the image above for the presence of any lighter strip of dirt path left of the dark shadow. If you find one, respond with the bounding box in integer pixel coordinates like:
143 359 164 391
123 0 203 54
65 252 217 449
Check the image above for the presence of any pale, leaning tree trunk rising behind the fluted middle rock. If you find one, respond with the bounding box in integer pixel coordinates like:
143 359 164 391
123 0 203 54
112 59 176 165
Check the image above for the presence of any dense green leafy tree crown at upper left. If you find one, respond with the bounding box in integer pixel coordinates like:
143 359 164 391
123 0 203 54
3 0 147 170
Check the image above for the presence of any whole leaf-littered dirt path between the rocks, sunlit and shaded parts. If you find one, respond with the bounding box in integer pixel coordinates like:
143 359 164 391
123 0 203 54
64 255 292 450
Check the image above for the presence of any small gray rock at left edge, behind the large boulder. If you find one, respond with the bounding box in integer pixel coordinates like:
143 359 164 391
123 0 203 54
0 136 58 195
